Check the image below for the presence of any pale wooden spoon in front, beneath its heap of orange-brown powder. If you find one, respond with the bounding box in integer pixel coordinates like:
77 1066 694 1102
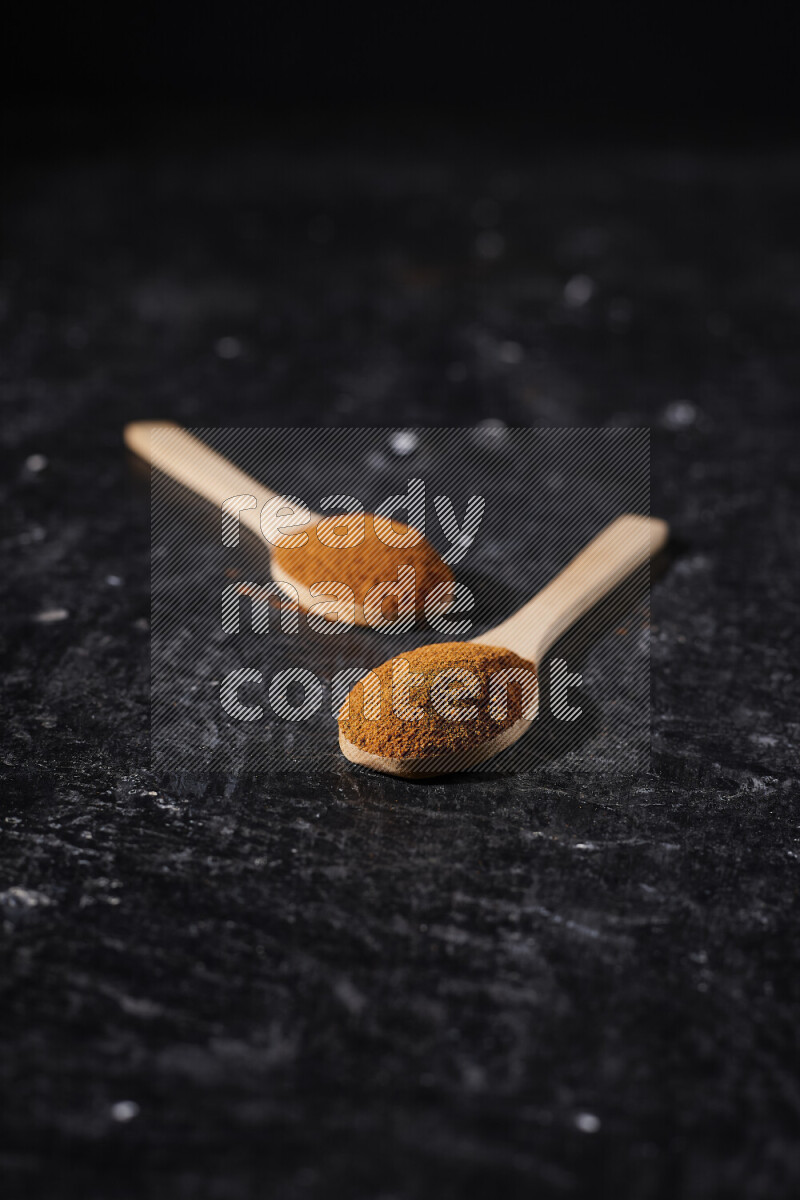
339 515 669 778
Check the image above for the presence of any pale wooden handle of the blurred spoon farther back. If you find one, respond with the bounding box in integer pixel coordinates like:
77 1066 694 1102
125 421 286 533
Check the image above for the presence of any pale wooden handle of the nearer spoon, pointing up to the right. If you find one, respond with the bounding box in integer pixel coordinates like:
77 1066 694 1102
475 514 669 666
